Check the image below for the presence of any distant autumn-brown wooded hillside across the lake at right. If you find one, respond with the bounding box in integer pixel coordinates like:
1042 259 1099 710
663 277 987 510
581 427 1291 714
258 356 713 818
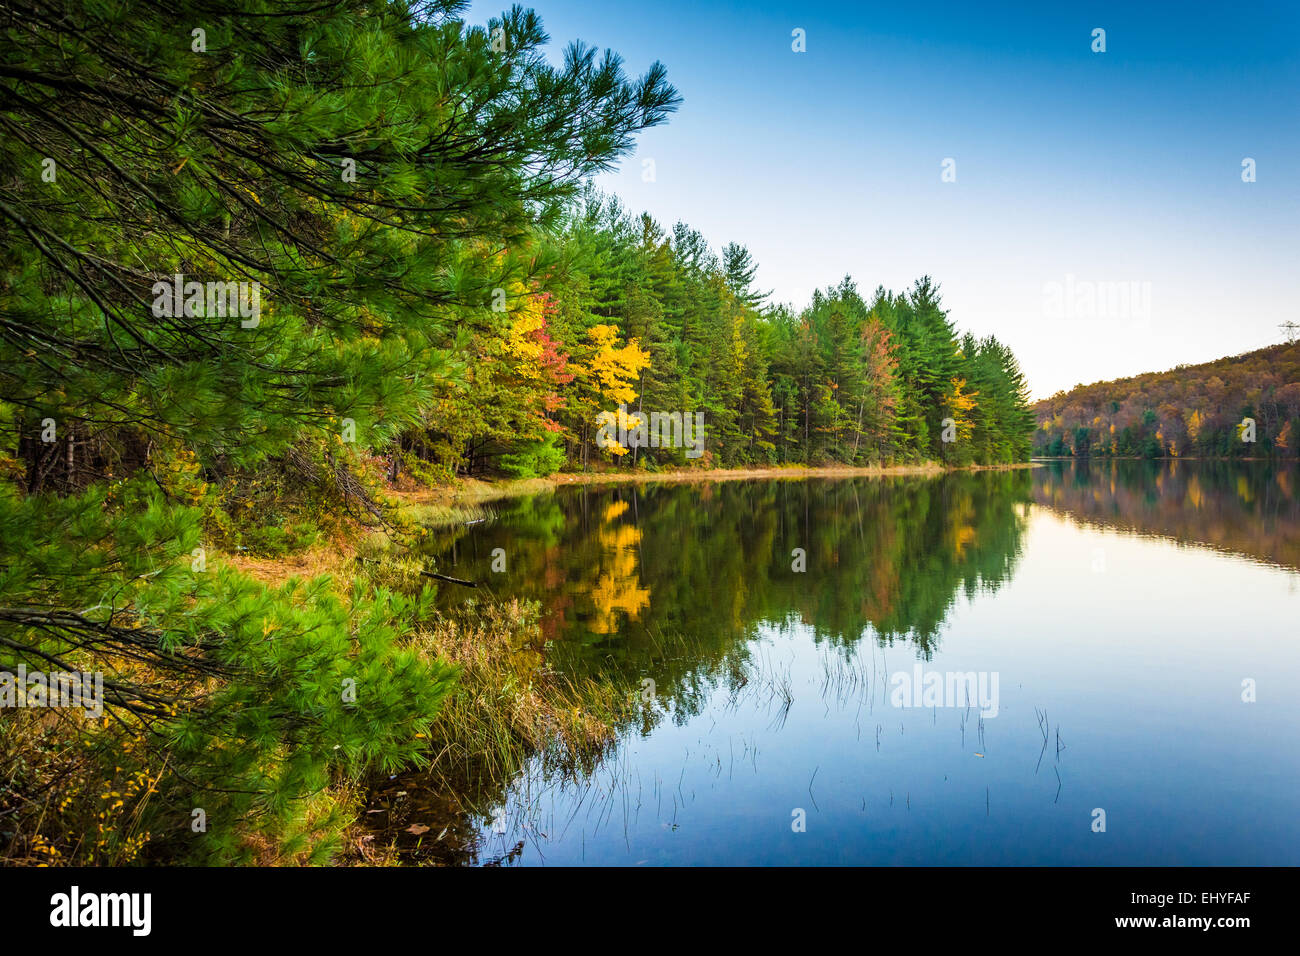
1034 342 1300 458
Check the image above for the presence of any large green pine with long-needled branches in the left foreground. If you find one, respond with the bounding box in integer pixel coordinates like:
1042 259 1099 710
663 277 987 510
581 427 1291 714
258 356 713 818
0 0 677 860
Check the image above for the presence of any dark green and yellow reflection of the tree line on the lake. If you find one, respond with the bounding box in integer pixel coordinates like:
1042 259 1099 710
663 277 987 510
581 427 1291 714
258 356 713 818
430 471 1032 675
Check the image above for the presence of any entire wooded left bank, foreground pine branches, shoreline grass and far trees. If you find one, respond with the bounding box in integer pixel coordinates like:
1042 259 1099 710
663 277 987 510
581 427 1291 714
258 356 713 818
0 0 1034 864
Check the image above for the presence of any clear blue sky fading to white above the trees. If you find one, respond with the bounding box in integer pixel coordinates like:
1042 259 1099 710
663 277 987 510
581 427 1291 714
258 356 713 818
467 0 1300 398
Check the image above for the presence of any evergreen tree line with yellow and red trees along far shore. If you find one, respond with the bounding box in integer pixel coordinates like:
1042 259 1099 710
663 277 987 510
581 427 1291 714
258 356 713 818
413 190 1034 476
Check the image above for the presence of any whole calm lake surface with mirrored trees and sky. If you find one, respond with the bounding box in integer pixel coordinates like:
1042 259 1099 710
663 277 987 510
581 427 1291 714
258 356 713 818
404 462 1300 865
